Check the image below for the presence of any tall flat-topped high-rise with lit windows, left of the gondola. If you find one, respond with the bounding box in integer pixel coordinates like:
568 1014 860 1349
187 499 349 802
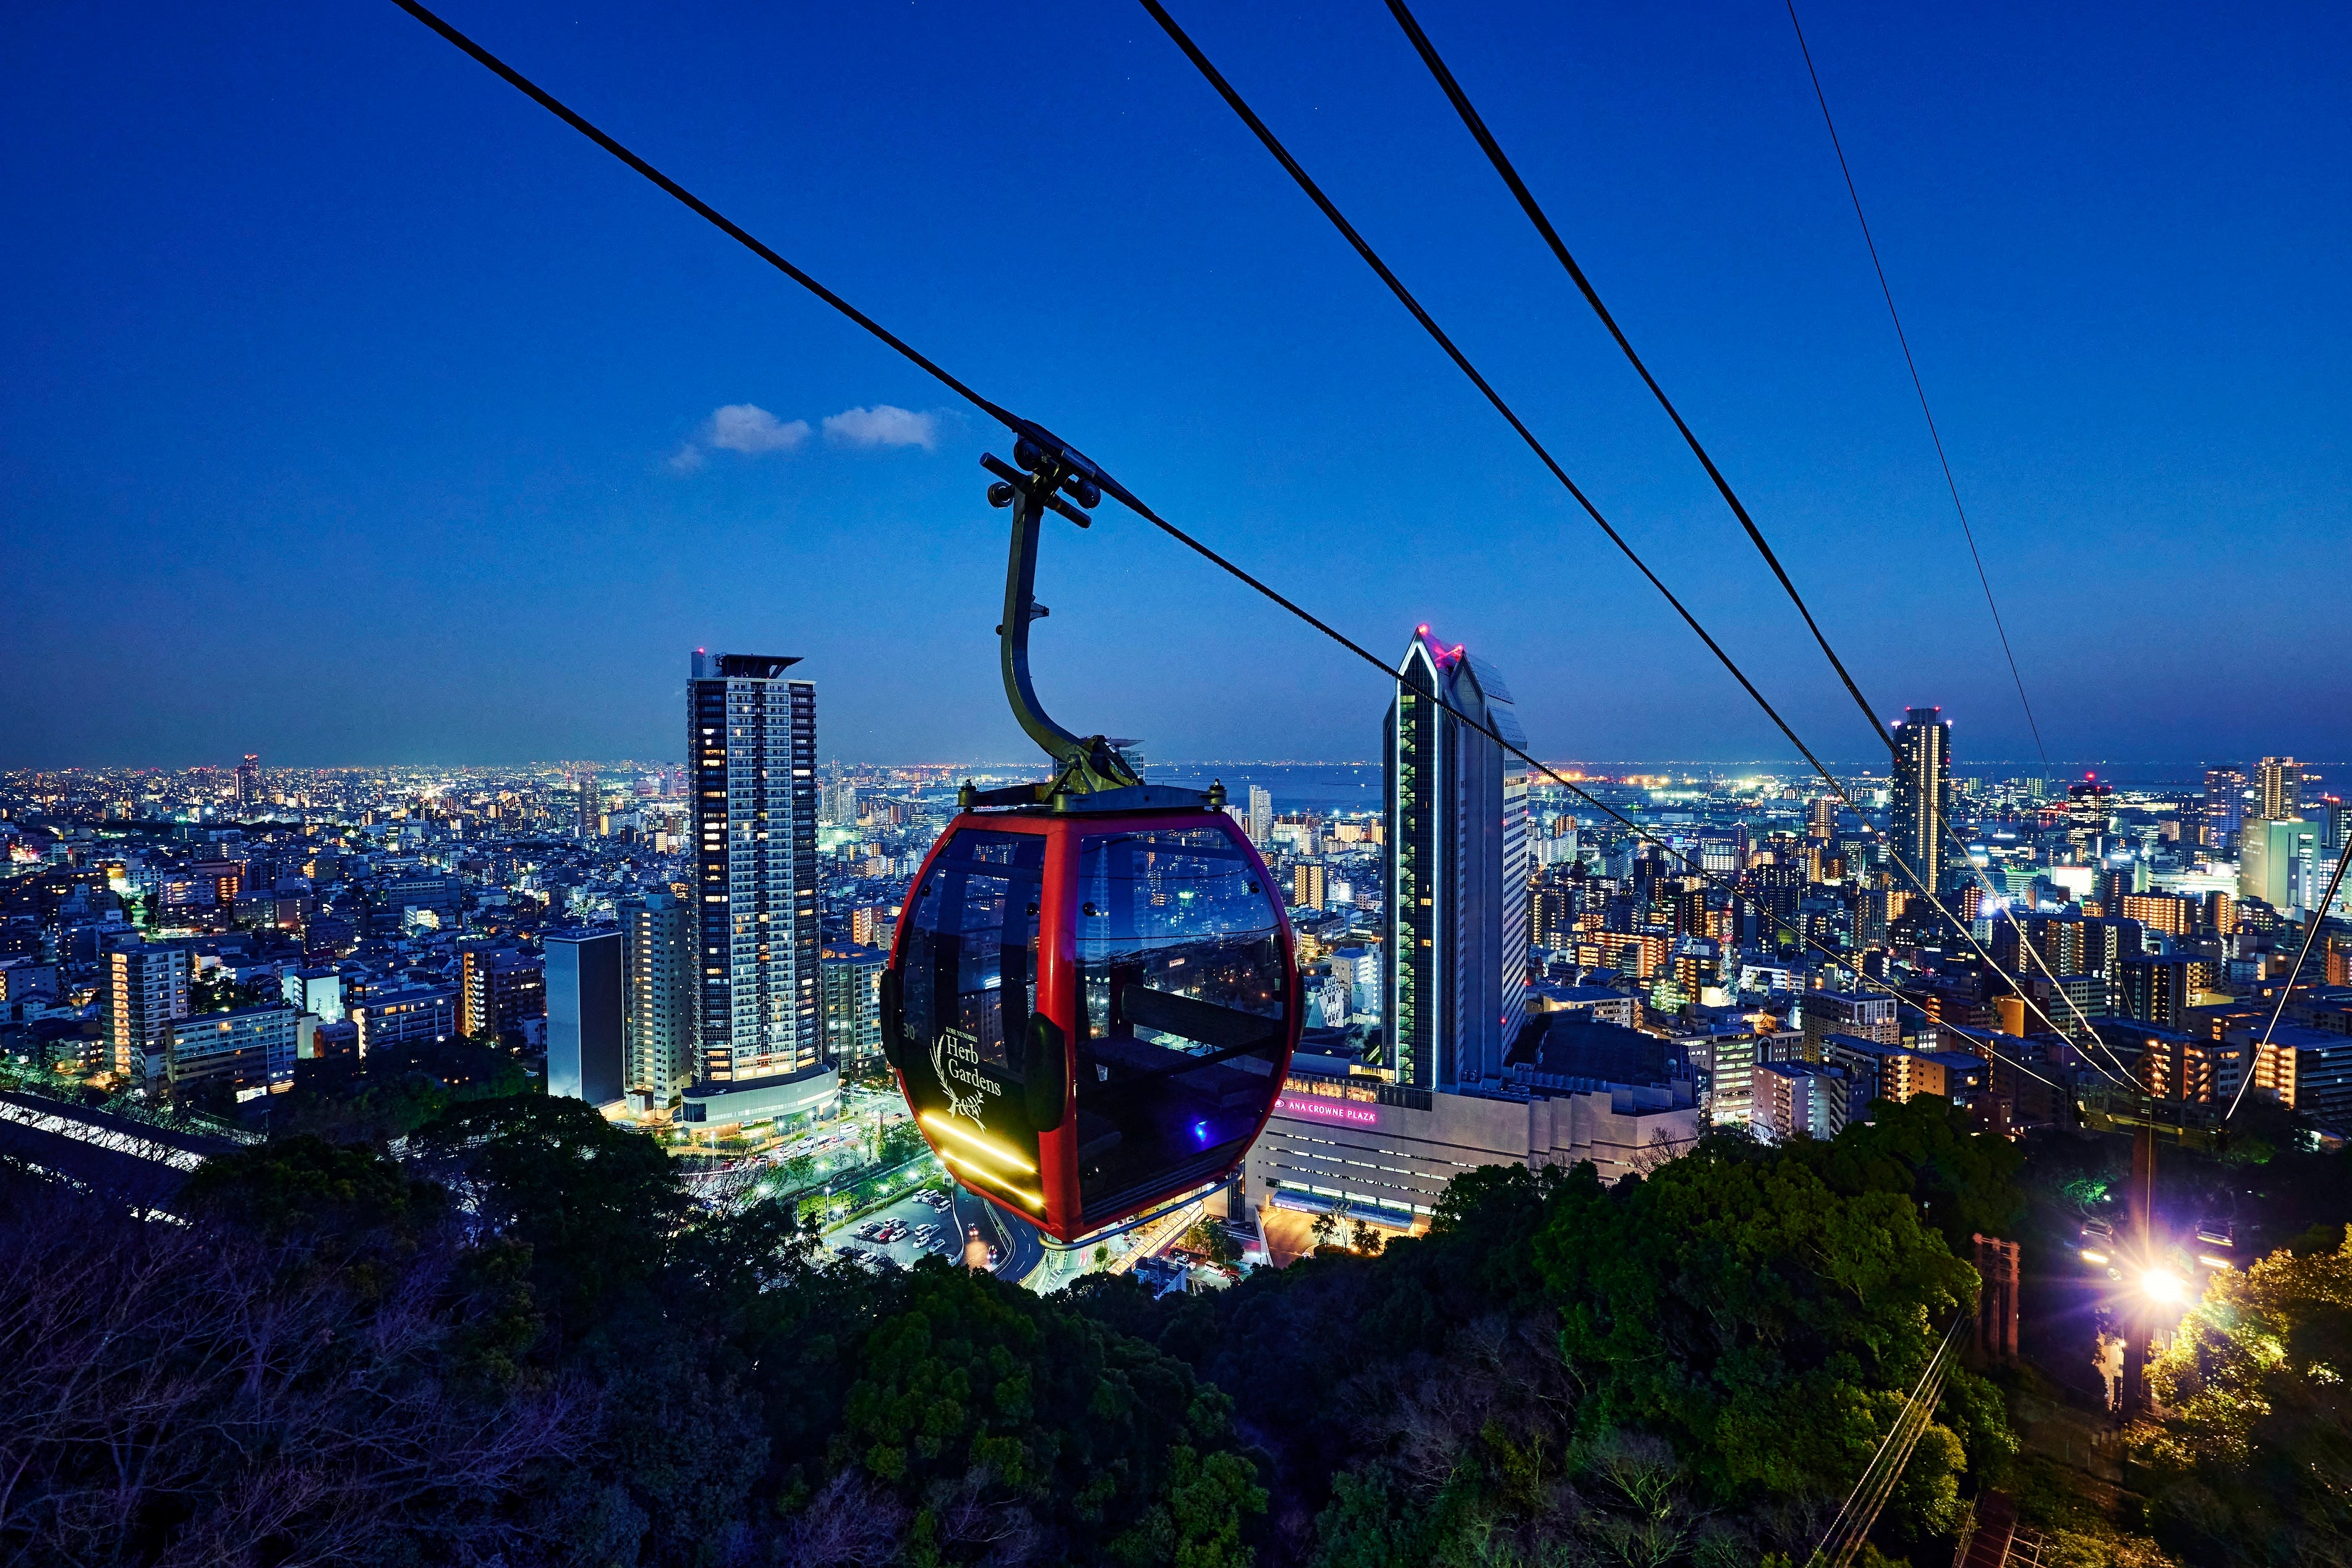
687 649 823 1086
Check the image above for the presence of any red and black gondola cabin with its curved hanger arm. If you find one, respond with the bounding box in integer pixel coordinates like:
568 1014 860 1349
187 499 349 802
882 425 1303 1243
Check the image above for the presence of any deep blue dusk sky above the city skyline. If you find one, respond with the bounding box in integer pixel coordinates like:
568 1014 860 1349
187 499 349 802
0 0 2352 766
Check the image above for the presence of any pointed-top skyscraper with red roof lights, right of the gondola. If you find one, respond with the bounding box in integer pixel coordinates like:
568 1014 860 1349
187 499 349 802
1381 628 1529 1088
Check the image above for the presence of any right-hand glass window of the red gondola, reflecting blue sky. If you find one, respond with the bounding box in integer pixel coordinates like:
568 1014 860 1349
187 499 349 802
1075 827 1289 1222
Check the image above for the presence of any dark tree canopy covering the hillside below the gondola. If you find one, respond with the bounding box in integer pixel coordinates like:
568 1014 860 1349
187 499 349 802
0 1096 2041 1568
